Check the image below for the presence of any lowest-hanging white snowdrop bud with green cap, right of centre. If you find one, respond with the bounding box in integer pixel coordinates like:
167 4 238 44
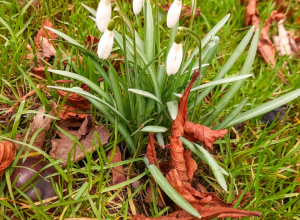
166 33 183 76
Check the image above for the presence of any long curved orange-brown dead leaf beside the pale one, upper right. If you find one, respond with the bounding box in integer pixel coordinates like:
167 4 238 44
257 11 287 83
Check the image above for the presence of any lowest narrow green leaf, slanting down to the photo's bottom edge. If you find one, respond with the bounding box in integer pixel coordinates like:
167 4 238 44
144 157 201 218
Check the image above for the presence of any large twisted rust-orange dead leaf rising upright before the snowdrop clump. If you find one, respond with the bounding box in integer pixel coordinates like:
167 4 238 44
138 70 261 220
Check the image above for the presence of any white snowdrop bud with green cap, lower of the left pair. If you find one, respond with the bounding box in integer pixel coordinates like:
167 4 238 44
97 20 115 60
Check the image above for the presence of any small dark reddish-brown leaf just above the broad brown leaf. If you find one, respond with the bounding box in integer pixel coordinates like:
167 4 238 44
56 83 90 111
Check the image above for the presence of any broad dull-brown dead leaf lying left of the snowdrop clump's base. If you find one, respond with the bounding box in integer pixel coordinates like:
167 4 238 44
50 115 110 165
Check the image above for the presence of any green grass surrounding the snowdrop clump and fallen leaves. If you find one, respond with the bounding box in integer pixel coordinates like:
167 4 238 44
0 0 300 219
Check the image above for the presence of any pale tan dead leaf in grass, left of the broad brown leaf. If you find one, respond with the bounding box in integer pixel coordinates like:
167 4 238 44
15 101 57 152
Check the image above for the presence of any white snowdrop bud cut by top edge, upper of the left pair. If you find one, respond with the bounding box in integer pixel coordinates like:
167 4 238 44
96 0 111 33
